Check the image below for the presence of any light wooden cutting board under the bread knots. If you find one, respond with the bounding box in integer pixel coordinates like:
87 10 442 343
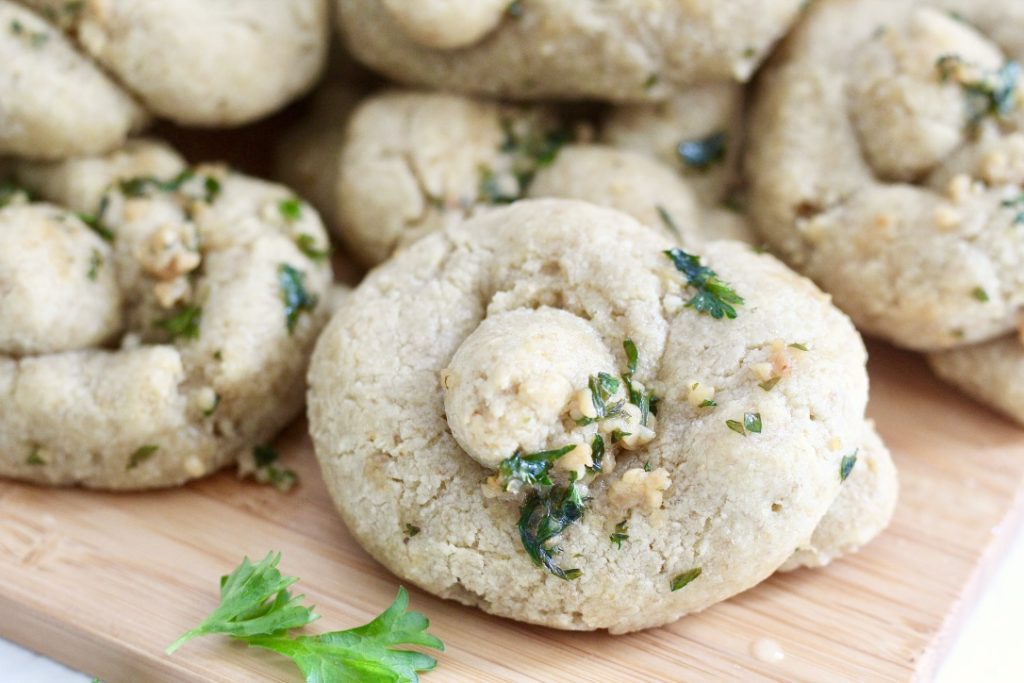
0 346 1024 683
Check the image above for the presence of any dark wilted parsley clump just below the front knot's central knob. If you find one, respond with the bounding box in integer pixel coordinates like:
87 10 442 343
519 481 586 581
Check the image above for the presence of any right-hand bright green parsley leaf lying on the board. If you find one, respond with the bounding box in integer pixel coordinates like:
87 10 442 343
246 588 444 683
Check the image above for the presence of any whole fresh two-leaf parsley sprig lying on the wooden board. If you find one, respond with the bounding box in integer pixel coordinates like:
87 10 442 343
167 553 444 683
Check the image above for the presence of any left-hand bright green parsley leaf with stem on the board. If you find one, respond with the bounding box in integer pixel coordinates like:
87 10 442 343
167 553 319 654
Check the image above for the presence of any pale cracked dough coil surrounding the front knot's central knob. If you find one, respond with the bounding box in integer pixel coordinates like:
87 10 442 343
308 200 884 632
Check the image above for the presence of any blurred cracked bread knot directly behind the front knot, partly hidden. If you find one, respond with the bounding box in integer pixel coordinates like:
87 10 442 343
281 84 754 265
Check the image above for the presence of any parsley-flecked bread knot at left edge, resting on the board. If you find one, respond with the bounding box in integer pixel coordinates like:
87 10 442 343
0 140 331 489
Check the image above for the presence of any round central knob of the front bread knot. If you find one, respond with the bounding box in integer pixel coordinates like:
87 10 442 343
441 307 622 469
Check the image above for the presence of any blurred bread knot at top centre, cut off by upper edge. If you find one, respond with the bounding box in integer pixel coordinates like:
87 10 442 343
335 0 801 101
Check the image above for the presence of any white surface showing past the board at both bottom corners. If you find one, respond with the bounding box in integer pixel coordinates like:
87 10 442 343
0 529 1024 683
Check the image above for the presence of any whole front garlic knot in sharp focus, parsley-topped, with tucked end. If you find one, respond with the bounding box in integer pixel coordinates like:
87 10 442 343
308 200 895 633
